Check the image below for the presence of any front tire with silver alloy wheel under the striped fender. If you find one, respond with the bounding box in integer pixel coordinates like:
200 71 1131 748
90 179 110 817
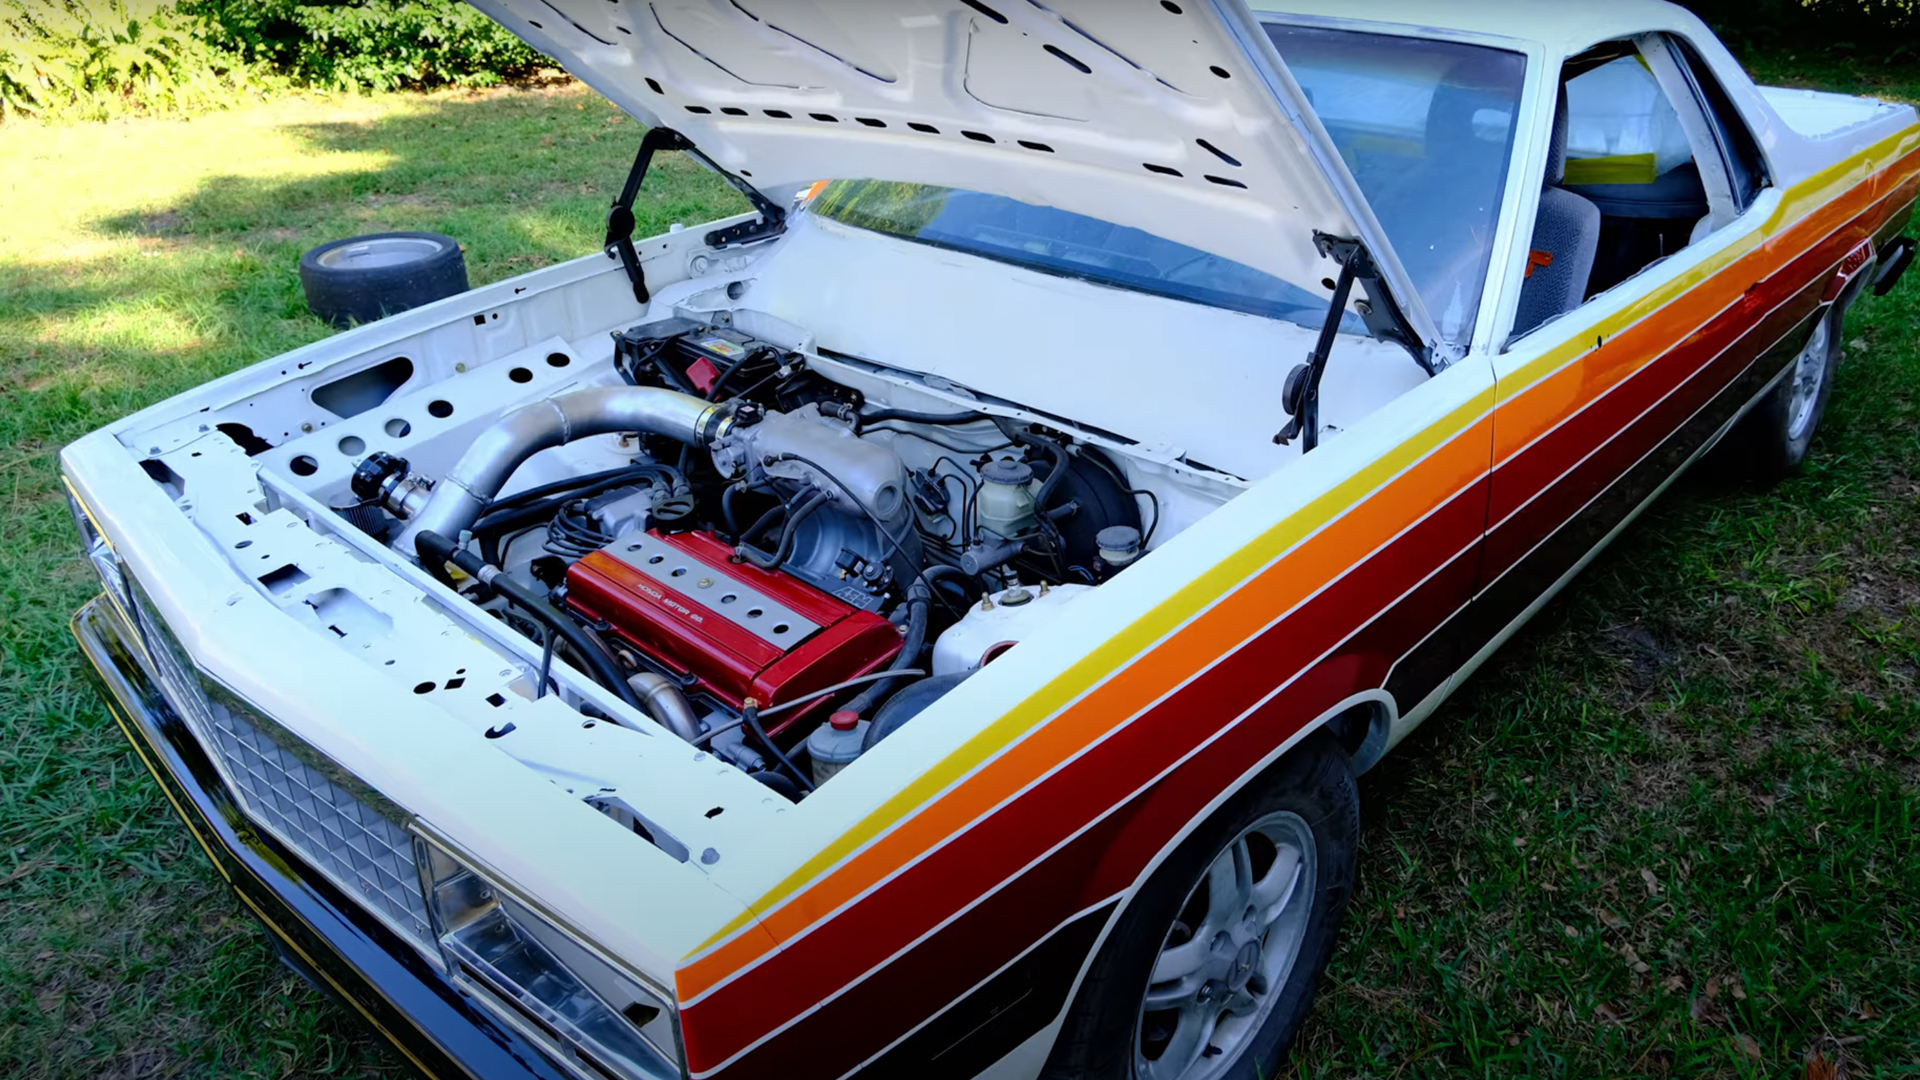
1046 734 1359 1080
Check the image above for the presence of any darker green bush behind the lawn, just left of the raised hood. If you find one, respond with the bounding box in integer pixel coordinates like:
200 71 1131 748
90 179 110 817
180 0 547 90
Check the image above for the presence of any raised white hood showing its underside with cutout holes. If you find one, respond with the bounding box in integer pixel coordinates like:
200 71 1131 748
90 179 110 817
470 0 1438 356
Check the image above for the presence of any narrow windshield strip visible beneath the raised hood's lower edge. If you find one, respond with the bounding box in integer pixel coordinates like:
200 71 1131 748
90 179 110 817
810 181 1365 332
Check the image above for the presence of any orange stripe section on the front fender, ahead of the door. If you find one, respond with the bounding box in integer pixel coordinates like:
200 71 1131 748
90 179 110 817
676 409 1492 999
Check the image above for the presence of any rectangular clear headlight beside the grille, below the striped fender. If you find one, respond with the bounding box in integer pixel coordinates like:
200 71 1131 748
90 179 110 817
419 840 680 1080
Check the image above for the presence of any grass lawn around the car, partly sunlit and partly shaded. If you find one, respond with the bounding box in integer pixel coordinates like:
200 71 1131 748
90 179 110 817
0 60 1920 1080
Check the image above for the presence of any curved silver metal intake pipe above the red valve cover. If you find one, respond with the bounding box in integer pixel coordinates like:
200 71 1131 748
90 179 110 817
394 386 732 555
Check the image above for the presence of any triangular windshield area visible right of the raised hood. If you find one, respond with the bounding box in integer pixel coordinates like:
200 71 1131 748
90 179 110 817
1267 23 1526 342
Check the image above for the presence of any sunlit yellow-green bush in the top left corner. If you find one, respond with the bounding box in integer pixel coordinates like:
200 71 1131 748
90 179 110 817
0 0 257 119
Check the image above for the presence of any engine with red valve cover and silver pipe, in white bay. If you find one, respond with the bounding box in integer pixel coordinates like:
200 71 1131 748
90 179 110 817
353 319 1158 798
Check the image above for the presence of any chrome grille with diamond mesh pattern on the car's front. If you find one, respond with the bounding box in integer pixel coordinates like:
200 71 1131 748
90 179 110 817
132 586 438 945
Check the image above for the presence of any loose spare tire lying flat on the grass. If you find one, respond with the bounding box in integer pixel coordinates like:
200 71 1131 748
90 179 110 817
300 233 467 329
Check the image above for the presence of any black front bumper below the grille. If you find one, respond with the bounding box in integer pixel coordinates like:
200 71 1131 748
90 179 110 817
73 596 570 1080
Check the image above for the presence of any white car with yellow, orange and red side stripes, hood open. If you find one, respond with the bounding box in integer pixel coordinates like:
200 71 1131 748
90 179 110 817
61 0 1920 1080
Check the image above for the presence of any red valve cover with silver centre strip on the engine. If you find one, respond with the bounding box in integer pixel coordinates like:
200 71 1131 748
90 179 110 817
566 532 900 732
